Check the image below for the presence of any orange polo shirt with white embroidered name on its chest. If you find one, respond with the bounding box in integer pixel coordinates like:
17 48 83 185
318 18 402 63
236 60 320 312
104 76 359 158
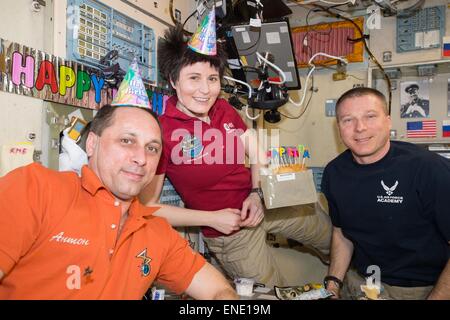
0 164 205 299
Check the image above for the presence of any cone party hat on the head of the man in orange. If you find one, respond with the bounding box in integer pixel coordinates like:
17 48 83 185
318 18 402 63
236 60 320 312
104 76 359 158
111 58 150 108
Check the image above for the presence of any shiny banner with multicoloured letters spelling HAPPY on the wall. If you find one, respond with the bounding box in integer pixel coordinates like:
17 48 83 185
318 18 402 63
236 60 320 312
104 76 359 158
0 38 116 109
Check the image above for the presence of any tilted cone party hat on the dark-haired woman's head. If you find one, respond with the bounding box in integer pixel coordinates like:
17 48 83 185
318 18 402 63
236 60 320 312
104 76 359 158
188 10 217 56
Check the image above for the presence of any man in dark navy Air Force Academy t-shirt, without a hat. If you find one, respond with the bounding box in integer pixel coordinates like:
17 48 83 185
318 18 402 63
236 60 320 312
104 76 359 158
322 88 450 299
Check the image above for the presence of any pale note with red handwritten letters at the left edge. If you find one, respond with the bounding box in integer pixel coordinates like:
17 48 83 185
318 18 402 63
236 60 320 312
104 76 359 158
0 144 34 177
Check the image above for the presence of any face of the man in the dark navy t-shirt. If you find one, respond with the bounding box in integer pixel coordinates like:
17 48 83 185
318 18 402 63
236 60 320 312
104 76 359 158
337 95 392 164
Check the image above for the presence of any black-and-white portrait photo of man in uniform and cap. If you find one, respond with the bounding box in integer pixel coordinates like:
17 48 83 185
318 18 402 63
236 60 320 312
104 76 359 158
400 81 430 118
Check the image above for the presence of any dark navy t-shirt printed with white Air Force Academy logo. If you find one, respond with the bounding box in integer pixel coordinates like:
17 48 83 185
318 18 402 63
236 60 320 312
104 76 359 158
322 142 450 287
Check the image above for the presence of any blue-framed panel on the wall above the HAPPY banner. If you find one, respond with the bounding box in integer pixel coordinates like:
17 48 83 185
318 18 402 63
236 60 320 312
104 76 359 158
67 0 157 84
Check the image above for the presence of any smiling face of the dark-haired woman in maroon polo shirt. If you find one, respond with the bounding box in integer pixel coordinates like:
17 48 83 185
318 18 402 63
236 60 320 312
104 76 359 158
171 62 220 119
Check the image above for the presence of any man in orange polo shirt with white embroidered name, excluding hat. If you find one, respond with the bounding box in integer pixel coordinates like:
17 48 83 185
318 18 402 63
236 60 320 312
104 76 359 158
0 61 237 300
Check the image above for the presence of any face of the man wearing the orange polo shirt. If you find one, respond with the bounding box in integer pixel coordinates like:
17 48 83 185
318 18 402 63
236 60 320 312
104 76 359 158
86 107 162 201
